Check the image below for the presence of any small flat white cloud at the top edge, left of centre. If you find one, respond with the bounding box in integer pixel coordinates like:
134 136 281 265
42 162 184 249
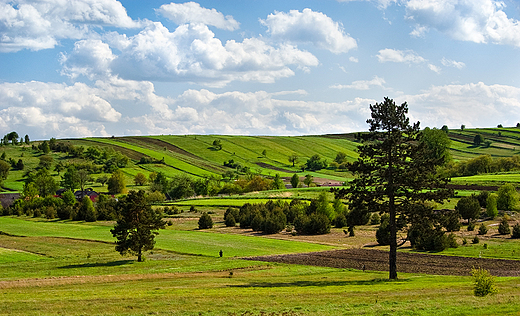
157 2 240 31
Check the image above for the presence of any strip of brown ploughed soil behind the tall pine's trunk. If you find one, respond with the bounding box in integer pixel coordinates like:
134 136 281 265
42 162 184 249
246 249 520 276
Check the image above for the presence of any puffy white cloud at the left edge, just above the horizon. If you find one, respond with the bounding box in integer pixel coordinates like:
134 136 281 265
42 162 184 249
0 81 121 136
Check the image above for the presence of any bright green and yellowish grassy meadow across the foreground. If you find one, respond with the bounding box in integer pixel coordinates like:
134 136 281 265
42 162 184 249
0 217 520 315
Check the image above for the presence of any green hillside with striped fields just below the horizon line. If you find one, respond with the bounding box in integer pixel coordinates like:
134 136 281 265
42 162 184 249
0 128 520 191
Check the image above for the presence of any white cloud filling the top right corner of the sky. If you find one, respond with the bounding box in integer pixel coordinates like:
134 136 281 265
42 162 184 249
404 0 520 47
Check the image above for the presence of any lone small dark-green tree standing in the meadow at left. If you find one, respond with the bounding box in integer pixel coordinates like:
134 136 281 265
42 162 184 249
110 190 166 262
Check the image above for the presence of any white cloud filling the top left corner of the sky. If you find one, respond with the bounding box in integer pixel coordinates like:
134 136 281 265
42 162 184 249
0 0 140 52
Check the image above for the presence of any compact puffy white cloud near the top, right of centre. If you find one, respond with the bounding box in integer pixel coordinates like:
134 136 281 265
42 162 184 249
260 9 357 54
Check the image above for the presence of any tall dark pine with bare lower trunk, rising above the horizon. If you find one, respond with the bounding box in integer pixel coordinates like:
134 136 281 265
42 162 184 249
334 98 452 279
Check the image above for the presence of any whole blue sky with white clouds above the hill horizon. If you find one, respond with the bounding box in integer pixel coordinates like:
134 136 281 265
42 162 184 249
0 0 520 139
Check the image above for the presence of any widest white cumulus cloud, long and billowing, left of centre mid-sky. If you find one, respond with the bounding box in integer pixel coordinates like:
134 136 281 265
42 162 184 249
62 22 318 86
